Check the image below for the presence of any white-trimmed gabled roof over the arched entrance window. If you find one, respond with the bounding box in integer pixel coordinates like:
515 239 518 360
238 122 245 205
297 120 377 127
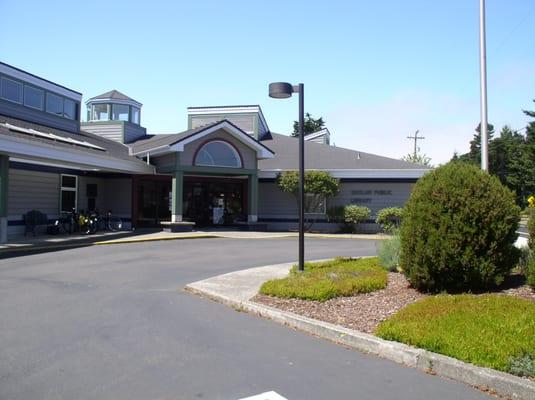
128 119 274 158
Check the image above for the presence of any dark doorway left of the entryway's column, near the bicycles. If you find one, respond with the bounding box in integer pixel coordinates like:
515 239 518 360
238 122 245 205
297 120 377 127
134 176 171 227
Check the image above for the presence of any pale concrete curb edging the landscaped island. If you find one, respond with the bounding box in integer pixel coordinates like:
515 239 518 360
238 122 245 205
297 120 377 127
185 263 535 400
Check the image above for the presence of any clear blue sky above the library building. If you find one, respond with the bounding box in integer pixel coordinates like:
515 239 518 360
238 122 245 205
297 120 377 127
0 0 535 163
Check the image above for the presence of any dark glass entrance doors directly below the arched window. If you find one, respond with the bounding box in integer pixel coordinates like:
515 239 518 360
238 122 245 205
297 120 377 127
183 177 247 226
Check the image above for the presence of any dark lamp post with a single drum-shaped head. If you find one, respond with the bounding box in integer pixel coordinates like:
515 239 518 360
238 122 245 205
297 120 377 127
269 82 305 272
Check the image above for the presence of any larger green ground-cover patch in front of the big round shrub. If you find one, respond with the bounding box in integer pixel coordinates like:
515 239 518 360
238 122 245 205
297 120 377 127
376 294 535 375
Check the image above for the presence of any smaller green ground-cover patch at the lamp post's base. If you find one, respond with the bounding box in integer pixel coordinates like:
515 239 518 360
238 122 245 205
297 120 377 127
260 257 388 301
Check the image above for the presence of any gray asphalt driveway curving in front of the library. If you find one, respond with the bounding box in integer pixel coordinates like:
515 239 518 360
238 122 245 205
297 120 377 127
0 238 488 400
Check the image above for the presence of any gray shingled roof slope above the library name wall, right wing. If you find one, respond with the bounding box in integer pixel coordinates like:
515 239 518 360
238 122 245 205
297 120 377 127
258 133 431 178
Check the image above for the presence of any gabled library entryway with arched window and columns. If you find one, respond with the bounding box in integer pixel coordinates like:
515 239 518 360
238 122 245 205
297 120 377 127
132 120 274 226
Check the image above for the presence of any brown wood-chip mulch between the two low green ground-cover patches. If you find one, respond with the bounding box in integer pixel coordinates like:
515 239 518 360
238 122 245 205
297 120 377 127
252 272 535 333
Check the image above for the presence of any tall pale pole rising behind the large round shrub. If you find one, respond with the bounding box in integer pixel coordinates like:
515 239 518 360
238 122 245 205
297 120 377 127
479 0 489 171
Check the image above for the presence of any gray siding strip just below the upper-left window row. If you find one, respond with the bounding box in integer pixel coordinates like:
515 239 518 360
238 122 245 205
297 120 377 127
0 99 80 133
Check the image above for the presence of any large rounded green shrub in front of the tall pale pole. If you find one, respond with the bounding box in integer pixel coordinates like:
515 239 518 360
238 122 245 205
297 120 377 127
400 163 519 291
